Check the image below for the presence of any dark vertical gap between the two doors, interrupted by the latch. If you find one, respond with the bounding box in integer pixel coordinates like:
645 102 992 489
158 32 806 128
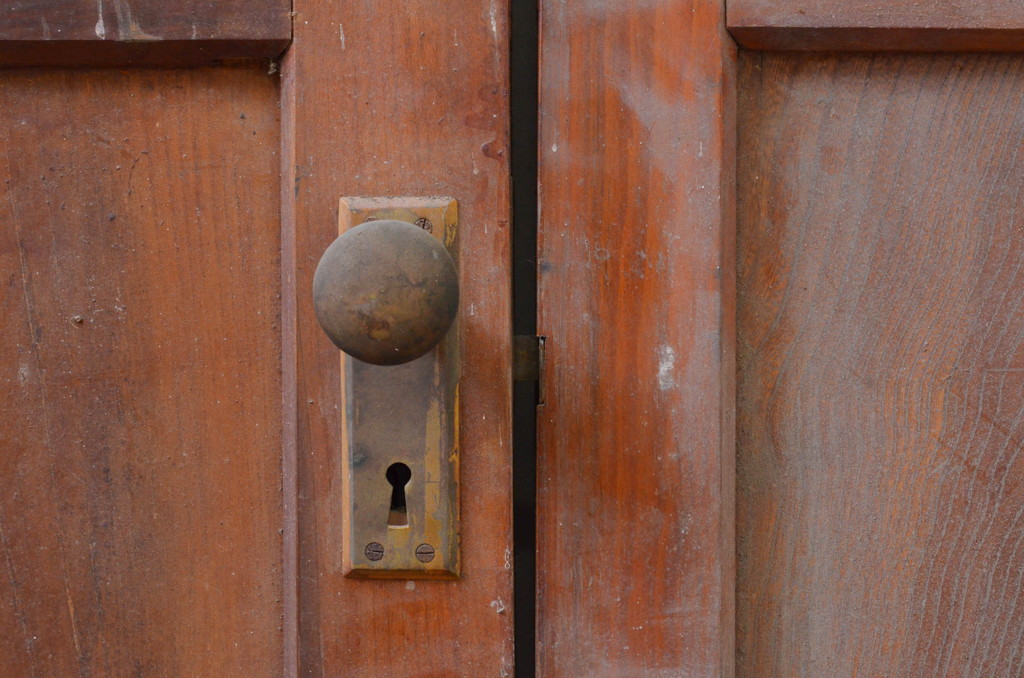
509 0 540 678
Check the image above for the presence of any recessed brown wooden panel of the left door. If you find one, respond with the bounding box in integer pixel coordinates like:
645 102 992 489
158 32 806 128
0 68 282 678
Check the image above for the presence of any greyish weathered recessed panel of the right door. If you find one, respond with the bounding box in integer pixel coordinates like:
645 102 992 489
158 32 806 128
737 54 1024 678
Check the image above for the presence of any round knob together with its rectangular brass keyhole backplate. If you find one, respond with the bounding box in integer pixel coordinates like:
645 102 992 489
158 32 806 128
312 196 462 580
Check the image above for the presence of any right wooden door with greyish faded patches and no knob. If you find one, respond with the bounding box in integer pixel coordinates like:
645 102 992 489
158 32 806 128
538 0 1024 677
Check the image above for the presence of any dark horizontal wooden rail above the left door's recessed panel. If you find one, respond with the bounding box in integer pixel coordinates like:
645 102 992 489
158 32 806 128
0 0 292 67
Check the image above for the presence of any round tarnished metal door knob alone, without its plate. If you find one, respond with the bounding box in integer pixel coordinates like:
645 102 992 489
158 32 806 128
313 219 459 365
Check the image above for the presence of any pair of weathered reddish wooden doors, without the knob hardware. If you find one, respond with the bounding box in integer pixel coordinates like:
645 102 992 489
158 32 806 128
0 0 1024 678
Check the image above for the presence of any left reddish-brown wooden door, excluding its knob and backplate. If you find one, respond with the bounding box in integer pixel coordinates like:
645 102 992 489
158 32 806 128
0 0 512 677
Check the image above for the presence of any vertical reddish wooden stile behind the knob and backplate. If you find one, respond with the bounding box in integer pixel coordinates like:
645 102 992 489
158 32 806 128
284 0 512 678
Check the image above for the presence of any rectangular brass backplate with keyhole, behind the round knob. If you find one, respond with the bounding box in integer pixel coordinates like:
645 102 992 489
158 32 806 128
339 198 461 580
